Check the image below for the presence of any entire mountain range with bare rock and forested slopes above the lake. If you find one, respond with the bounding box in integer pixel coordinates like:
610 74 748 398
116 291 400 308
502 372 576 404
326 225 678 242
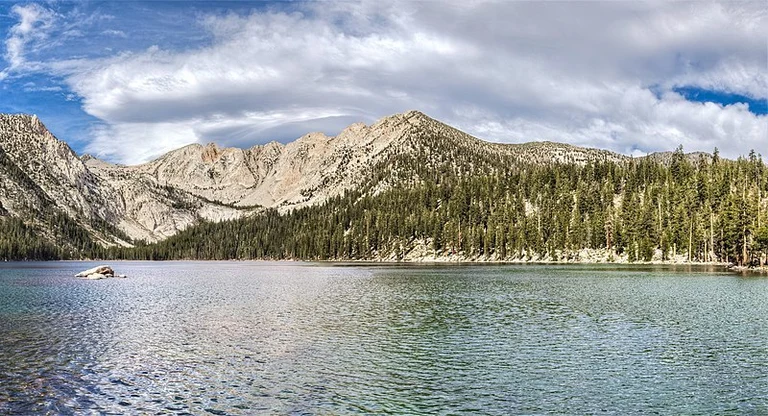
0 111 768 263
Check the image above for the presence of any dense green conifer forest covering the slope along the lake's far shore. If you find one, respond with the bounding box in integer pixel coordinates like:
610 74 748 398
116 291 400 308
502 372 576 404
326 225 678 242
94 147 768 264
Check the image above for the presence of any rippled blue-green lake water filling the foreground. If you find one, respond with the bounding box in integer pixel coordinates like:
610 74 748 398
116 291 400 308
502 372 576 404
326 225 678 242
0 262 768 415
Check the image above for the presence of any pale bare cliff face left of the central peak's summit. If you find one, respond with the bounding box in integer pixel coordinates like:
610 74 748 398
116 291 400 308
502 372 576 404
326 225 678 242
130 112 436 208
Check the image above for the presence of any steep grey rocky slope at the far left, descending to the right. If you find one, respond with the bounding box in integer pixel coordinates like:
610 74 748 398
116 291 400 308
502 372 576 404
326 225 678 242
0 115 255 245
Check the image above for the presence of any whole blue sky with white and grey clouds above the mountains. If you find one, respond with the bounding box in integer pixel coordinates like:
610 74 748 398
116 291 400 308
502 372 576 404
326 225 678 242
0 0 768 164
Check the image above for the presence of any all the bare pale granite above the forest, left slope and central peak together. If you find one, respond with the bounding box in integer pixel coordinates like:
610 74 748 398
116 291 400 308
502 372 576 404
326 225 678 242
0 111 628 245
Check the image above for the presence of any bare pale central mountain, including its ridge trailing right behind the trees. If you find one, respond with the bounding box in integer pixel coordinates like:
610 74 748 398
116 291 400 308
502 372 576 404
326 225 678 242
125 111 626 207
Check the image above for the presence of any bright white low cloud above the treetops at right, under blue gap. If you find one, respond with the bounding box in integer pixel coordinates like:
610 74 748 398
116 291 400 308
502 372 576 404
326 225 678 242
466 88 768 157
